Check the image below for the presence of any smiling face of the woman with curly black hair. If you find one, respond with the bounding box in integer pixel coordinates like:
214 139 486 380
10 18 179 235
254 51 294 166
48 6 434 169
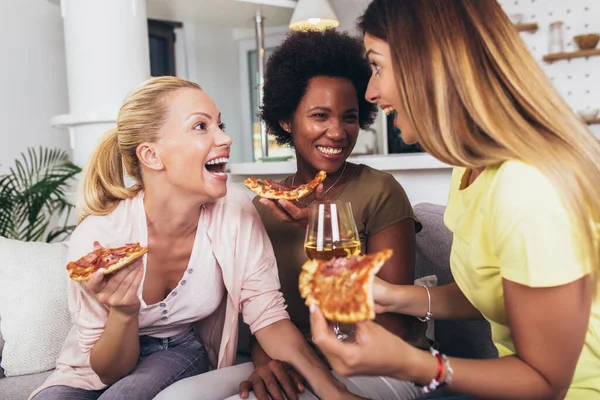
281 77 360 174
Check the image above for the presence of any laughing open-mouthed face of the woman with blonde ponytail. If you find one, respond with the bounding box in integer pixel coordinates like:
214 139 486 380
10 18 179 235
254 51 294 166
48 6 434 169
138 88 232 200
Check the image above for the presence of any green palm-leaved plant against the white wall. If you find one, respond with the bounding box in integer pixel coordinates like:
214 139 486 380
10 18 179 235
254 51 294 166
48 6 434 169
0 147 81 242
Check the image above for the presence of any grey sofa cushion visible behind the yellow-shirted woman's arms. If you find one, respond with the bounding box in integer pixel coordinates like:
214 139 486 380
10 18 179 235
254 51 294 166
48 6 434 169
414 203 498 358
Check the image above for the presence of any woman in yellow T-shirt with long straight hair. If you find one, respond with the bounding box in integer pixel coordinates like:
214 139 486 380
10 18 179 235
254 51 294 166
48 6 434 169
311 0 600 399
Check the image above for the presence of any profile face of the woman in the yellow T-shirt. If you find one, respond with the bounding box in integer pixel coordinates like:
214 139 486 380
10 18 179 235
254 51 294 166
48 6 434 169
364 34 417 144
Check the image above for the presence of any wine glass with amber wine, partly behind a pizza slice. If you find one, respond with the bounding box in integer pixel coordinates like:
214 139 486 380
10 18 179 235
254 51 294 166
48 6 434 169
304 201 361 340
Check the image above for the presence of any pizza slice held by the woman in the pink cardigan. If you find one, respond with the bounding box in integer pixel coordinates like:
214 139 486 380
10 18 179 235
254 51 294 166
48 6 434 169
67 242 148 282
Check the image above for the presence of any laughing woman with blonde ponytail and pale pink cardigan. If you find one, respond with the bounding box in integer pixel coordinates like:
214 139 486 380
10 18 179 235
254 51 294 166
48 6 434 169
32 77 356 400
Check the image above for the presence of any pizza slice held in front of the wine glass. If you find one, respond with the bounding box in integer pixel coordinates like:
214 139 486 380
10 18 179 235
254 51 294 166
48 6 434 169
299 249 392 324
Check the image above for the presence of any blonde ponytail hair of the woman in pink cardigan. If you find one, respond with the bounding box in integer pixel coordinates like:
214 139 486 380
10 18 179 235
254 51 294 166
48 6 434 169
77 76 201 222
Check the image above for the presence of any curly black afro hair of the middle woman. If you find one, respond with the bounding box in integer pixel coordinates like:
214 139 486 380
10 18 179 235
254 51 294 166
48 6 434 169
259 29 377 145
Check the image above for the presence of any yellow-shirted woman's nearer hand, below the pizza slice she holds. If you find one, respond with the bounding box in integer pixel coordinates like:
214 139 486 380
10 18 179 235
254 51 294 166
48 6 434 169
310 305 415 379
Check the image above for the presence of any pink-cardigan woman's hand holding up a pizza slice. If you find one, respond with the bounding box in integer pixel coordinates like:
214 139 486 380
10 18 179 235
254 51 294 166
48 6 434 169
86 258 144 316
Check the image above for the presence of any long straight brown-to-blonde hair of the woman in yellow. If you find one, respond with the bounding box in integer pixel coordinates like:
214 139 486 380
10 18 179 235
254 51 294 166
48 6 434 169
359 0 600 279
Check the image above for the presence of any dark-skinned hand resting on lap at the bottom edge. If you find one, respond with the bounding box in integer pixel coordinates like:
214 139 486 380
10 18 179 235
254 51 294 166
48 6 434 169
240 360 304 400
